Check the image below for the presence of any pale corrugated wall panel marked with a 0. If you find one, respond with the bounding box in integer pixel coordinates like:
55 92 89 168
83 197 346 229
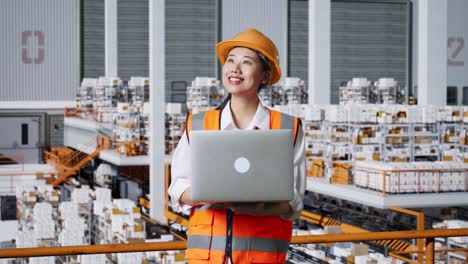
0 0 80 104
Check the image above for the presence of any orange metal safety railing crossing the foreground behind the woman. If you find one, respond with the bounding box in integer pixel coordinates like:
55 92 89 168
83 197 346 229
0 228 468 264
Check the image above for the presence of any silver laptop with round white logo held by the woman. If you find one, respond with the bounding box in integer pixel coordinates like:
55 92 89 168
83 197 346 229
190 129 294 202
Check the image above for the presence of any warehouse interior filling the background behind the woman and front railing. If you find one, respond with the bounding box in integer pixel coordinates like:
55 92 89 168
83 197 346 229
0 0 468 264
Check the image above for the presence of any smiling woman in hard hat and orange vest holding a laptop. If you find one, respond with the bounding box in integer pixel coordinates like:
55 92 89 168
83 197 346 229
169 29 305 264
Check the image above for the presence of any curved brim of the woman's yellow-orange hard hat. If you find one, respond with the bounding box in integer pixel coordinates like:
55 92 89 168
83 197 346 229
216 40 281 85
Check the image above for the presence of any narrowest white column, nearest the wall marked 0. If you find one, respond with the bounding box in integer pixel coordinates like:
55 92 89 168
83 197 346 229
104 0 118 77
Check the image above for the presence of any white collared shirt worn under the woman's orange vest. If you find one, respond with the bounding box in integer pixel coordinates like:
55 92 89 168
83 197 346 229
168 102 306 220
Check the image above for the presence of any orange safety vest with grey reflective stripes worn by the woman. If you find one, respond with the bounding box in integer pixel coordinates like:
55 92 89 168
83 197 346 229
186 105 300 264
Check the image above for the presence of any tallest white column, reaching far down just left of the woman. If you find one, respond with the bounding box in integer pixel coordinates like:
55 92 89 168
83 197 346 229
149 0 166 223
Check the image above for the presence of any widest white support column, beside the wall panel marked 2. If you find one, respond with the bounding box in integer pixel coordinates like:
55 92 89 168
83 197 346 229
418 0 447 105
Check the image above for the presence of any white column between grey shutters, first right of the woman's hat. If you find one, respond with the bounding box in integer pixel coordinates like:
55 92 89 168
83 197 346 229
308 0 331 105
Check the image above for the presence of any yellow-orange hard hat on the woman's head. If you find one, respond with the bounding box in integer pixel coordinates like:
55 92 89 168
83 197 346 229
216 28 281 84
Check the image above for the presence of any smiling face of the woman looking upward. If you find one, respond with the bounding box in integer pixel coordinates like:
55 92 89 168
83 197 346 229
223 47 269 96
